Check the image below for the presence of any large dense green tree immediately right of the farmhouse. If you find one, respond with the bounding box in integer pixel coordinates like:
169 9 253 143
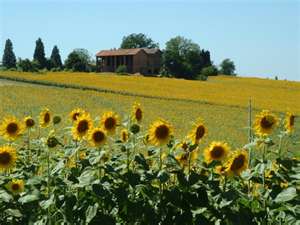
163 36 211 79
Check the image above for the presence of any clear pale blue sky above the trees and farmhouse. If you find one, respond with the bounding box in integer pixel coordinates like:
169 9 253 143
0 0 300 80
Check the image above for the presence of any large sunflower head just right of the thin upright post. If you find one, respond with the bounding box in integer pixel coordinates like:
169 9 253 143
254 110 278 136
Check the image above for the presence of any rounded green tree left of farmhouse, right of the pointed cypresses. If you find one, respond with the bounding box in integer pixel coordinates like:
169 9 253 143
65 49 92 72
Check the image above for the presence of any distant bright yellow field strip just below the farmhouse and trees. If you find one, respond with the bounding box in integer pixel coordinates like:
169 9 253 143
0 72 300 114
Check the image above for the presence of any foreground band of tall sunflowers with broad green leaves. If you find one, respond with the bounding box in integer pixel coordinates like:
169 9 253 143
0 103 300 225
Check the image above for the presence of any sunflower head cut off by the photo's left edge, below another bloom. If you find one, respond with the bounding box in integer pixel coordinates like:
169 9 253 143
0 145 17 171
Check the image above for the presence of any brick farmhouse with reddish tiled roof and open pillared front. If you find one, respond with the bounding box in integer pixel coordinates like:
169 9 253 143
96 48 162 74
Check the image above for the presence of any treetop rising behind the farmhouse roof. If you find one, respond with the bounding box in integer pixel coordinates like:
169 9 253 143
120 33 158 49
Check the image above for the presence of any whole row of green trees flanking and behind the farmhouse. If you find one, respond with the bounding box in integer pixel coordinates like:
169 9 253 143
2 33 235 80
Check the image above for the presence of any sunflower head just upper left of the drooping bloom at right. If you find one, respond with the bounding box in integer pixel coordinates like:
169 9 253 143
204 141 229 163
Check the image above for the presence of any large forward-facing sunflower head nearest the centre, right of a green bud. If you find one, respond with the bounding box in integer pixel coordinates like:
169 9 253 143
149 119 173 146
